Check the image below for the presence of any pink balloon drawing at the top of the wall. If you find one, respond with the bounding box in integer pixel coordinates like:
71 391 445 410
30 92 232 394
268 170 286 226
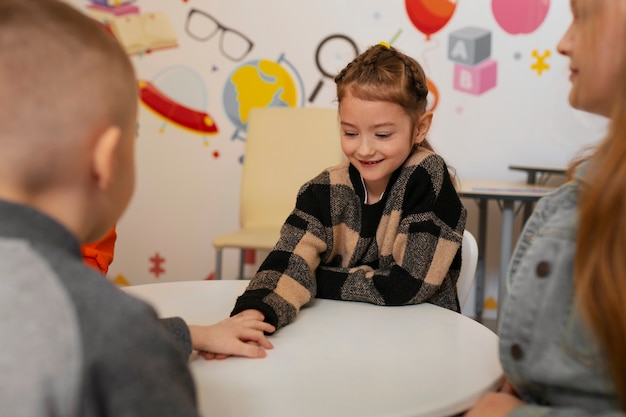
491 0 550 35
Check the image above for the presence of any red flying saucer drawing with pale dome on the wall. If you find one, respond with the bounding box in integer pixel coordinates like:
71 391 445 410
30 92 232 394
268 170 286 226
138 67 218 135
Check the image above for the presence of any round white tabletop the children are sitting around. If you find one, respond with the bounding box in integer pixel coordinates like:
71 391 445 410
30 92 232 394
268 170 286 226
124 280 502 417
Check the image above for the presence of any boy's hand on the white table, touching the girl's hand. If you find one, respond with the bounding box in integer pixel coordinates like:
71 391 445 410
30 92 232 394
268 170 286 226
189 310 276 359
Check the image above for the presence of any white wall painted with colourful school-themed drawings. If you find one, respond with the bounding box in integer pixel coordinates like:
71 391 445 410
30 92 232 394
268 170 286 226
68 0 605 313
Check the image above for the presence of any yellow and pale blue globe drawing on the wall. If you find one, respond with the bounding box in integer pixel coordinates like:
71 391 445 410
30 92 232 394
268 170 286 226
223 56 303 139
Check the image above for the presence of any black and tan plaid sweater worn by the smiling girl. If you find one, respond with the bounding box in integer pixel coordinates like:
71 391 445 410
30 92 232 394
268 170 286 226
231 150 467 328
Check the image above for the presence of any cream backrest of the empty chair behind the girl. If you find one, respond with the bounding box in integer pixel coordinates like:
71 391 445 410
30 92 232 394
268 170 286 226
240 107 344 227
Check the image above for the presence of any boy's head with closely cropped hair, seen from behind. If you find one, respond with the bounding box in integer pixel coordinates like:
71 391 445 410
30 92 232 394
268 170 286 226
0 0 137 242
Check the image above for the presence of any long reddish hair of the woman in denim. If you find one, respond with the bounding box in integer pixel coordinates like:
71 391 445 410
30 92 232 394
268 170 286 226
574 26 626 410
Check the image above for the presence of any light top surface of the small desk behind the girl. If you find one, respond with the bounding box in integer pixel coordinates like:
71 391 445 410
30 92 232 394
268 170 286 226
459 179 555 201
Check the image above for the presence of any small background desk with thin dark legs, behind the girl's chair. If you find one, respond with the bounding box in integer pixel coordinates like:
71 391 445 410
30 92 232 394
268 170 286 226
459 180 554 321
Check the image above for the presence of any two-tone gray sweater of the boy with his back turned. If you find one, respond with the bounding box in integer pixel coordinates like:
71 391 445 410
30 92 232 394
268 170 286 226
0 201 198 417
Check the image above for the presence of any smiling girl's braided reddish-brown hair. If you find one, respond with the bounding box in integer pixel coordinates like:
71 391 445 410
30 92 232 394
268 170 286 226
335 44 433 151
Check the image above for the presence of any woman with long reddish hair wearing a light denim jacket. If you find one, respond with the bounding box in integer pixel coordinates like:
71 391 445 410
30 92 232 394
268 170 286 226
466 0 626 417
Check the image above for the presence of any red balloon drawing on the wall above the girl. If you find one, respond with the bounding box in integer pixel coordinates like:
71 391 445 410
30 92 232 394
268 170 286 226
404 0 457 40
